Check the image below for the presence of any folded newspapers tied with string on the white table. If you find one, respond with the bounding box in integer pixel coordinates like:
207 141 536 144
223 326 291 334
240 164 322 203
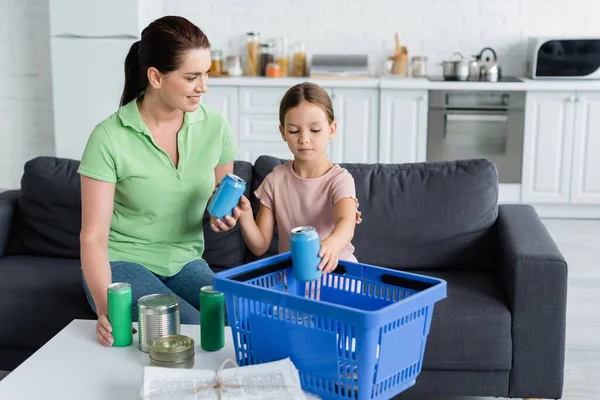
142 358 314 400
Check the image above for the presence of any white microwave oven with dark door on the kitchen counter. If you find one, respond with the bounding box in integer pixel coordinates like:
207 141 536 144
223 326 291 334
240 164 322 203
527 37 600 79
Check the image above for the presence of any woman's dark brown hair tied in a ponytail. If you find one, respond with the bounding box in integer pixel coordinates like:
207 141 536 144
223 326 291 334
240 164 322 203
121 16 210 106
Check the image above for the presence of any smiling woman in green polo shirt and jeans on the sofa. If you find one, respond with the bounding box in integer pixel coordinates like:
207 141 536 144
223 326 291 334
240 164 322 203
78 16 240 346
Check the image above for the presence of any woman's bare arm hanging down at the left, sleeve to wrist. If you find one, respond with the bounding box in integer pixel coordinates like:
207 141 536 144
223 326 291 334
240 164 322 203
79 176 115 316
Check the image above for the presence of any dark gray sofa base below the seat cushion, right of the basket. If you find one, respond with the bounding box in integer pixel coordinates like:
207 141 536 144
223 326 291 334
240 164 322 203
394 370 510 400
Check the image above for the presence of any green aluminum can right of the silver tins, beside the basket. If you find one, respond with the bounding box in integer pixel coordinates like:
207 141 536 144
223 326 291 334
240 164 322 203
200 286 225 351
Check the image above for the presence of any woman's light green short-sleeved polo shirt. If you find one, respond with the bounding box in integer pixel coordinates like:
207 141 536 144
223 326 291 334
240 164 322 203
78 100 237 276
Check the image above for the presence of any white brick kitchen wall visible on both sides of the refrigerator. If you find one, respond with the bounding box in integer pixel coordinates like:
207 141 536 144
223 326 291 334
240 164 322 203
0 0 600 188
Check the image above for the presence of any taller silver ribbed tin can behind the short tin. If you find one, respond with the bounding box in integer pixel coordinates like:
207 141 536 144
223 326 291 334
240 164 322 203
138 293 180 353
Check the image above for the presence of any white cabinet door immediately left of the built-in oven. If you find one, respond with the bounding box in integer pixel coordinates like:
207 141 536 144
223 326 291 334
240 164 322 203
378 89 428 163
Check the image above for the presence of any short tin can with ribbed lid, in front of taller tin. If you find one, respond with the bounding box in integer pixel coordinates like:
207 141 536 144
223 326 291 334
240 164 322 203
150 335 195 368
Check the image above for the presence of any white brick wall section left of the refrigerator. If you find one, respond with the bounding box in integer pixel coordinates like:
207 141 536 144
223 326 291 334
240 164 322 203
0 0 54 189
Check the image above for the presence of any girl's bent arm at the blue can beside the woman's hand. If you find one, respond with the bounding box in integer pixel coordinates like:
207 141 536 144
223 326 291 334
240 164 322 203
239 203 275 256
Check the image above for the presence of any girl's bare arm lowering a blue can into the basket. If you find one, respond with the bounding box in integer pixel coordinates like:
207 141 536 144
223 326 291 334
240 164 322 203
319 197 356 272
